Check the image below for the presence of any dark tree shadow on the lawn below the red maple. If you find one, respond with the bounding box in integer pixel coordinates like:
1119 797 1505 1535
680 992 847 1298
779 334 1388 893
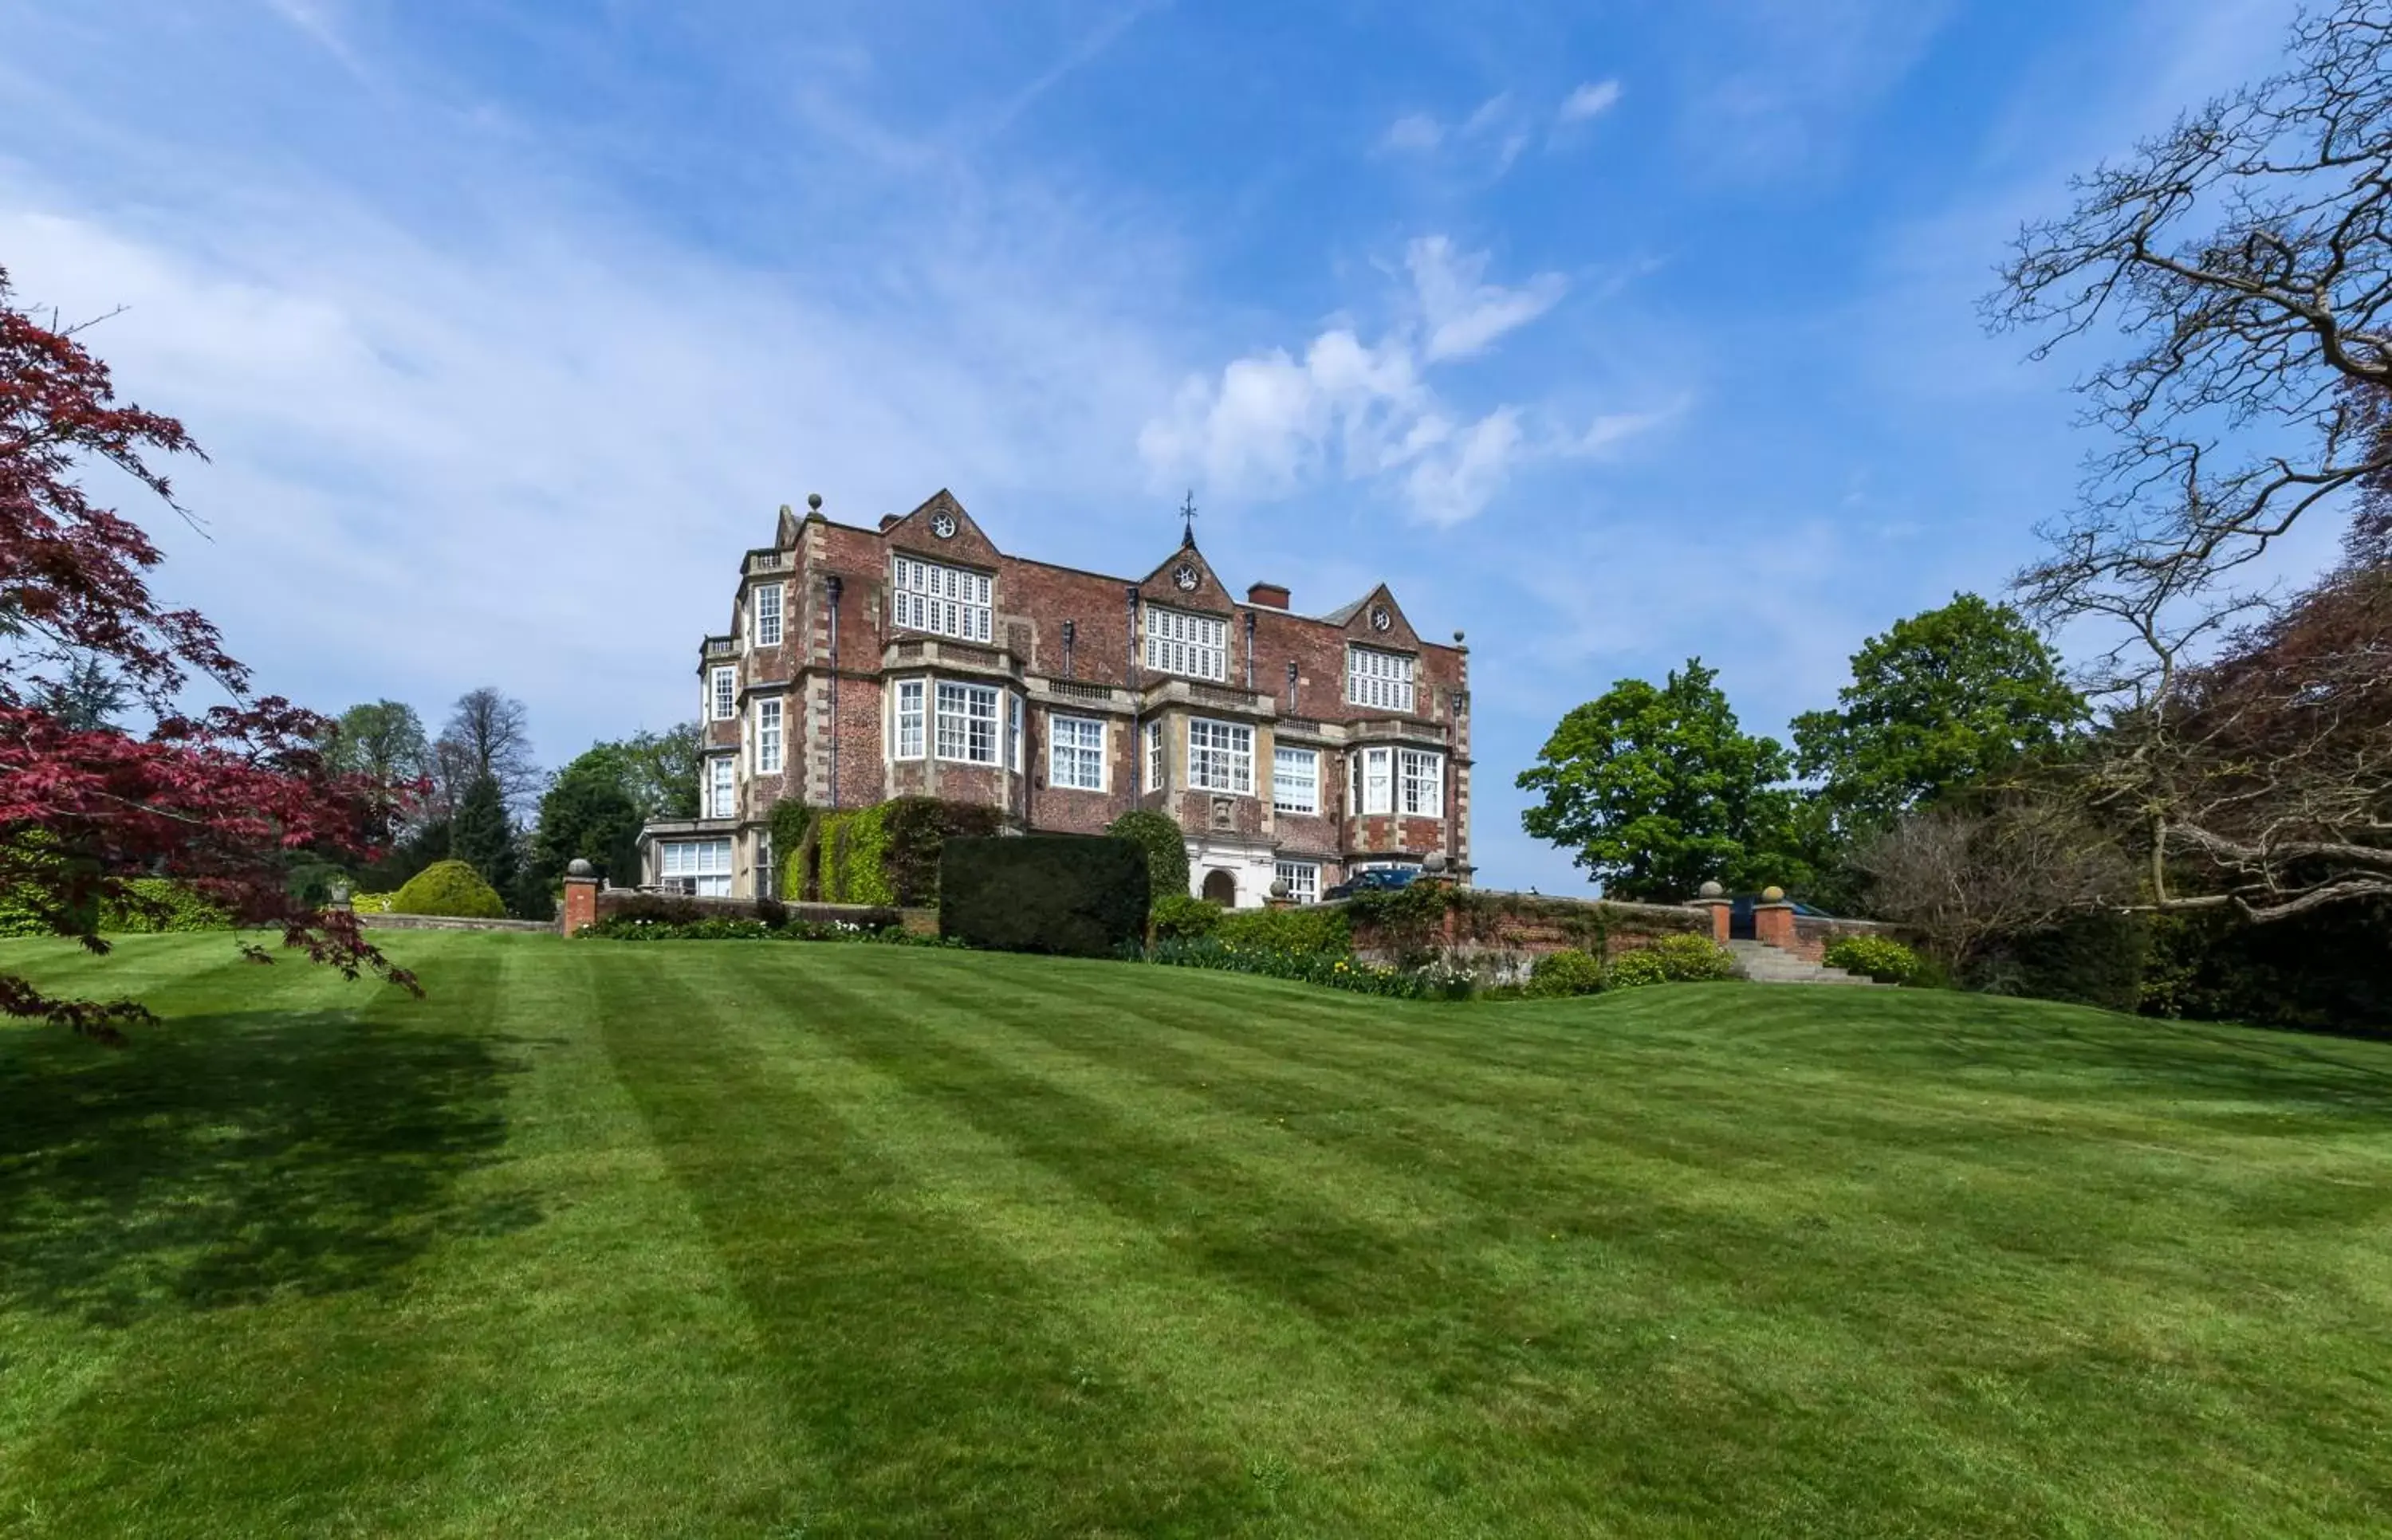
0 1012 538 1322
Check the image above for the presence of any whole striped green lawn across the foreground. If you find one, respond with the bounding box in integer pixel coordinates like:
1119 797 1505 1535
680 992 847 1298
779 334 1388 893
0 933 2392 1540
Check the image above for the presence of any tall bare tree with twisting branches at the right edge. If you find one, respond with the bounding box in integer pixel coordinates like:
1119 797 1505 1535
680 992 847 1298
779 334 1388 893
1988 0 2392 918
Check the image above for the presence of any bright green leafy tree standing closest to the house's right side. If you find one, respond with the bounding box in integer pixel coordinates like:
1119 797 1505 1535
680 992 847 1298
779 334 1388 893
1519 658 1808 899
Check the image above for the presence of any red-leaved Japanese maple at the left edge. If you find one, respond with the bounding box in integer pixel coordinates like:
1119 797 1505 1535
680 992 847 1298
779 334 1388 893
0 268 416 1043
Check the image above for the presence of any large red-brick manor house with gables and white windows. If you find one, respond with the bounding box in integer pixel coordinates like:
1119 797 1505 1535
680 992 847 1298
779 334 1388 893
641 493 1471 906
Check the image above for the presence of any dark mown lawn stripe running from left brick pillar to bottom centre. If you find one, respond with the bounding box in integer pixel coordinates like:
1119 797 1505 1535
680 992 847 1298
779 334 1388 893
586 947 1256 1535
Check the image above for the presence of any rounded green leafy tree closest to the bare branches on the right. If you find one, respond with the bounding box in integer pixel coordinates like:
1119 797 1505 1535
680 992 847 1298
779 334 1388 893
1794 593 2086 832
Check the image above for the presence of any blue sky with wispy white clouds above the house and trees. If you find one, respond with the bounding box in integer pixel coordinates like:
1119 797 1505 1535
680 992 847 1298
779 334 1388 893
0 0 2289 892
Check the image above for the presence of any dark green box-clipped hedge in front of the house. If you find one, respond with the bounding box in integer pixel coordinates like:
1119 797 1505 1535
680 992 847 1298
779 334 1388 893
938 835 1148 957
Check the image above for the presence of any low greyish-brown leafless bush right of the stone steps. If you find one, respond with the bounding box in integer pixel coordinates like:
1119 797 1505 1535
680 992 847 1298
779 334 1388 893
1859 796 2134 971
